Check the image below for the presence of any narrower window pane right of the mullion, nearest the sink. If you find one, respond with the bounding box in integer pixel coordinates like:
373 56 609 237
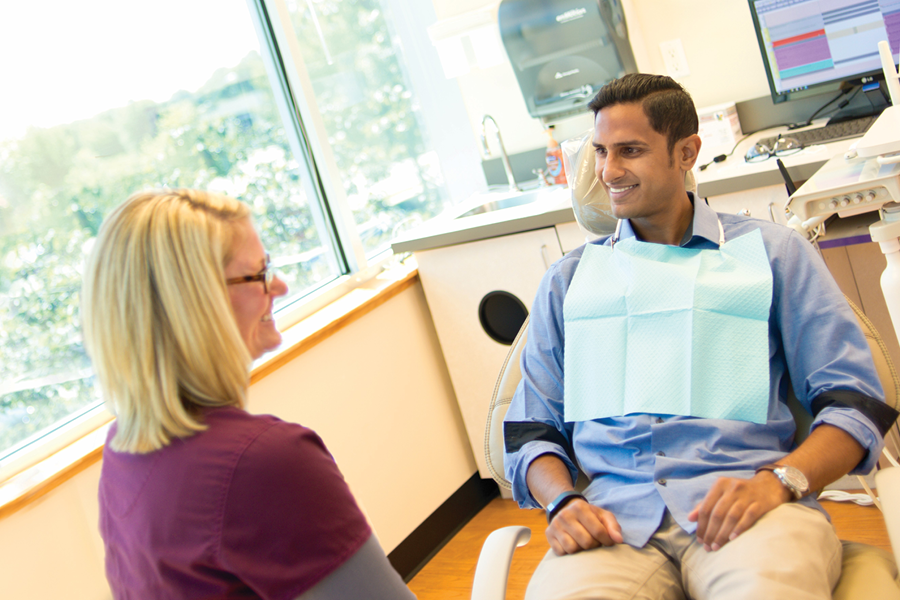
287 0 447 255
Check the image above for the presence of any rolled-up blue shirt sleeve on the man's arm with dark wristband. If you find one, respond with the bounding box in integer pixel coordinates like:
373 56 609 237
503 255 581 508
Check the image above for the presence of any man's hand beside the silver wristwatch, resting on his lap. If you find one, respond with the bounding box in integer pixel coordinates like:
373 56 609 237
688 471 793 551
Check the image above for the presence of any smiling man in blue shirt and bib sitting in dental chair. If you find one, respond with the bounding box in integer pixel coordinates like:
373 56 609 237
504 74 900 600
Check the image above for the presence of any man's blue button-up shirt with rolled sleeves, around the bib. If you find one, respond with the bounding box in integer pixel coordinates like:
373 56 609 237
504 200 884 547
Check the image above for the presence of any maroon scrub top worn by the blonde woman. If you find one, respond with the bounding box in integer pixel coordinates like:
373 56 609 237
100 407 372 600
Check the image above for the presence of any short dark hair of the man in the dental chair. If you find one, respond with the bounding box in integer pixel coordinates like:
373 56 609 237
588 73 699 154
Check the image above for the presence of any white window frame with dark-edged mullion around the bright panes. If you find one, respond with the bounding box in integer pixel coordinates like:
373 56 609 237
0 0 487 484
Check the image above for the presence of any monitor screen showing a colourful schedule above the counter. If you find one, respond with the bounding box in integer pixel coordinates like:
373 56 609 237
749 0 900 103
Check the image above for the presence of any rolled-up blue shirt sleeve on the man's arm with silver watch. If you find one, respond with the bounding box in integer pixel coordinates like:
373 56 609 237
772 227 896 474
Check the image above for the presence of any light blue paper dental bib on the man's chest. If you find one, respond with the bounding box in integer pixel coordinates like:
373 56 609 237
563 230 772 423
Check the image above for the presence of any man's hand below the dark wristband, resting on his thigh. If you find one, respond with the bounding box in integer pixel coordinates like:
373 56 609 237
546 498 622 556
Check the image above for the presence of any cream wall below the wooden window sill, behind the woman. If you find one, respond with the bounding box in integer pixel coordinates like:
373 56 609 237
0 284 476 600
